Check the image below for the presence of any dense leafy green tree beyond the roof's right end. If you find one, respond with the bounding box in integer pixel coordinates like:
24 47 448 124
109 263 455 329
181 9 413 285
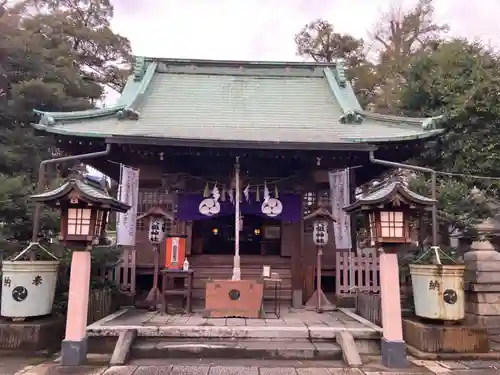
399 40 500 179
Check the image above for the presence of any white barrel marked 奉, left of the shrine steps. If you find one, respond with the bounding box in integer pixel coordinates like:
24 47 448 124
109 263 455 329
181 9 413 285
1 260 59 318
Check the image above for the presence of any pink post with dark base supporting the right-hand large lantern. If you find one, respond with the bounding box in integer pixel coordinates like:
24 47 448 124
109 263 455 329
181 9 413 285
380 253 408 368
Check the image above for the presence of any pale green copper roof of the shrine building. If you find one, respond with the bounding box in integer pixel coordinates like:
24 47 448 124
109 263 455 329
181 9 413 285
34 58 441 143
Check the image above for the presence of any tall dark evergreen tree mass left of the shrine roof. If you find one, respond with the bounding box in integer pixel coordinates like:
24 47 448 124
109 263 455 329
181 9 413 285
0 0 130 242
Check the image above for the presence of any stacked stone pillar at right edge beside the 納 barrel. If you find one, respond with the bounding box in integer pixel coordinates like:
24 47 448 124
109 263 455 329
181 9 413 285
464 240 500 336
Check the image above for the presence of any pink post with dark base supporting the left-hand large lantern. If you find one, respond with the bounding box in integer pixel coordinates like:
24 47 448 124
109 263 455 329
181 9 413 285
61 251 91 366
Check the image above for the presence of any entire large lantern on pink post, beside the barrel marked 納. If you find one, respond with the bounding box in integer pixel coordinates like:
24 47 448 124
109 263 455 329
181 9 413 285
344 181 436 367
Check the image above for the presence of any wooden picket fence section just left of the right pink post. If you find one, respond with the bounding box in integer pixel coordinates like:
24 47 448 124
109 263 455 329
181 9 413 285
335 249 380 296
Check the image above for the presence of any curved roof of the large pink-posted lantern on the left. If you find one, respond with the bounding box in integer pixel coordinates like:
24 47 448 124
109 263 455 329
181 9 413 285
30 178 130 213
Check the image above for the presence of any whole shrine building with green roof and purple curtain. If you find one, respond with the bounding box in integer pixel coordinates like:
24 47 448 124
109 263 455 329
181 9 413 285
33 57 441 303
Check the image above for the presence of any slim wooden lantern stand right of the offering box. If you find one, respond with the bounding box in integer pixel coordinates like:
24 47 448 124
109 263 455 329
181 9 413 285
304 202 336 313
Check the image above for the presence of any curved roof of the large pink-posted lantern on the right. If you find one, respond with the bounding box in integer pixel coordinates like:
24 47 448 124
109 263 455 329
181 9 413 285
344 181 436 213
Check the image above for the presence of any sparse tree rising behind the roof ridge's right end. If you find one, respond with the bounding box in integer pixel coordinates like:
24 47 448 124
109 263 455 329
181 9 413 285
295 19 377 104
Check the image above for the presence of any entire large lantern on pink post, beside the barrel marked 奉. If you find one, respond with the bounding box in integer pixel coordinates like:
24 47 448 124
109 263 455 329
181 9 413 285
31 178 130 366
